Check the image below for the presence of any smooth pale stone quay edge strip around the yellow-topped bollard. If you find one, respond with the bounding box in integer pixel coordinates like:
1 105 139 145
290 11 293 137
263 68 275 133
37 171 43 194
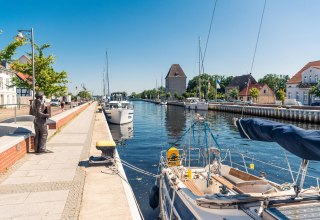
79 109 141 220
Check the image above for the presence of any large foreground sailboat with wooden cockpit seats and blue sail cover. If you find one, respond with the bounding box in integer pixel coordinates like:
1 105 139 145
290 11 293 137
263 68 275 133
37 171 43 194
150 118 320 220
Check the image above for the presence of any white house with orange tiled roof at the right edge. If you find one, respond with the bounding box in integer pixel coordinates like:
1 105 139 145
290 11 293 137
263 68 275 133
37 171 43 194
286 61 320 105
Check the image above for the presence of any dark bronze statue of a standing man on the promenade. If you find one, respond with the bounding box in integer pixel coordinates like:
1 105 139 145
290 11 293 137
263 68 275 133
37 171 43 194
32 92 51 153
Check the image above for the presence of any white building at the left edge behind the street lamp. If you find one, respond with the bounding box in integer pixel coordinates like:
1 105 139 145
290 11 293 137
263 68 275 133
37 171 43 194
0 65 17 108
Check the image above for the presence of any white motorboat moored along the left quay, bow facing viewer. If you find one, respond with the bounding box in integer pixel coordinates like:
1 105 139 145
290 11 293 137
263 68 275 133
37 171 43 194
105 92 134 125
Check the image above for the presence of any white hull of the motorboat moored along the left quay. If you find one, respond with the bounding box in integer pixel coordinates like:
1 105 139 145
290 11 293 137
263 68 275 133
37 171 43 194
106 108 134 125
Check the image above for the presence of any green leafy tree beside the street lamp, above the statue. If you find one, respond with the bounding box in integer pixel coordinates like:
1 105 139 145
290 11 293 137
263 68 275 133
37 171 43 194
11 44 69 97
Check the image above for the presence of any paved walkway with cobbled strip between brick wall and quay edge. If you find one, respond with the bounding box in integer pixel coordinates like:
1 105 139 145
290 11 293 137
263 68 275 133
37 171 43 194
0 103 96 220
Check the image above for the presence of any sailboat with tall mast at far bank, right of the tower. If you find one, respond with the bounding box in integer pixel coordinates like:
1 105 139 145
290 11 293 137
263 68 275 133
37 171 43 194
184 37 209 111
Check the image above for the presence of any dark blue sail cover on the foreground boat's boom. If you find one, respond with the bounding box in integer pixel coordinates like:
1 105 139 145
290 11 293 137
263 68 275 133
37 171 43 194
236 118 320 161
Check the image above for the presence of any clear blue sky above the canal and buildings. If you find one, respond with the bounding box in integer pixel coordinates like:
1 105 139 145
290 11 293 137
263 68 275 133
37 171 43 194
0 0 320 95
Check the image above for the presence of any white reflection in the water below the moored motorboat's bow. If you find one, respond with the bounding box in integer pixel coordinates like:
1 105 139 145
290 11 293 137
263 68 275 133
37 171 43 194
109 122 133 145
